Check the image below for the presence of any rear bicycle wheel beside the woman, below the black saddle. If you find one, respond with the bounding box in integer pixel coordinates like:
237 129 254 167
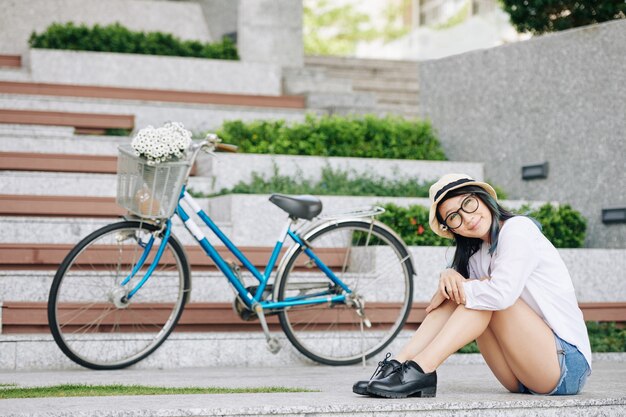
277 219 413 365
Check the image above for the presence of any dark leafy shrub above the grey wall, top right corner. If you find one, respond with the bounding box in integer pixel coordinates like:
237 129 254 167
502 0 626 34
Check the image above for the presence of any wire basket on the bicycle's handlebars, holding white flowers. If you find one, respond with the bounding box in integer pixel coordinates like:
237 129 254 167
117 145 190 219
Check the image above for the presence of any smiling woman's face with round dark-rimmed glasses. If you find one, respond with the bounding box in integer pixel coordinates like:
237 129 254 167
437 194 492 242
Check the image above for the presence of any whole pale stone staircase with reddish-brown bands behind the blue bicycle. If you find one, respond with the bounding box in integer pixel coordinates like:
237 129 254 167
0 43 626 370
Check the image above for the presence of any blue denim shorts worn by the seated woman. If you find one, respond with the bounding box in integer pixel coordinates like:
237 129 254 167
519 334 591 395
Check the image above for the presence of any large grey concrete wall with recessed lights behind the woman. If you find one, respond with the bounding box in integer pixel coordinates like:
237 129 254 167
419 20 626 248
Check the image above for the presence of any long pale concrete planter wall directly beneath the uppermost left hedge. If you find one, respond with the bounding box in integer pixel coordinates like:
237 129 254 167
22 49 282 96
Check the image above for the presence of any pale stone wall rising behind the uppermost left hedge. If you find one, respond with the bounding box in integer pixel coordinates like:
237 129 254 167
0 0 211 54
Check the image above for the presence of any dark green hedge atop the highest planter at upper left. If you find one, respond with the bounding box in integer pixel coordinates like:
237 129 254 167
29 22 239 60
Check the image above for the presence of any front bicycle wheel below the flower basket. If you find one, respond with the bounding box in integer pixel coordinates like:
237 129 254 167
48 221 190 369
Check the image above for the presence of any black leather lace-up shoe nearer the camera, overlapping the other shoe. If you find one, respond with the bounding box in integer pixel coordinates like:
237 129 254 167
367 361 437 398
